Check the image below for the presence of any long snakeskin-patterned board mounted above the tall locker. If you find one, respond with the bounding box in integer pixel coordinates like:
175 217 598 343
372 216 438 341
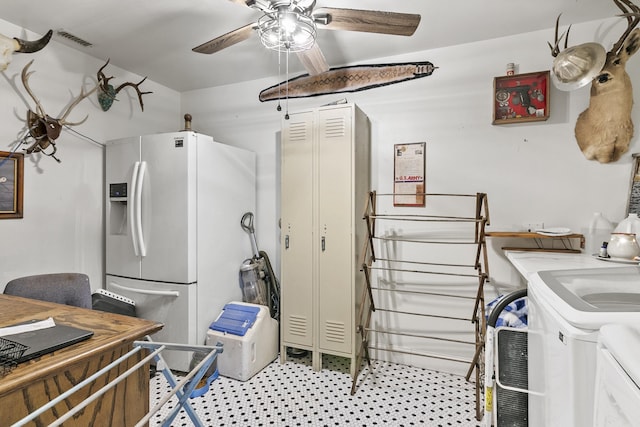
259 61 438 102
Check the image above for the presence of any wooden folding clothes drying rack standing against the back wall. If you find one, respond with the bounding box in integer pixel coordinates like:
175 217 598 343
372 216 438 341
351 191 489 420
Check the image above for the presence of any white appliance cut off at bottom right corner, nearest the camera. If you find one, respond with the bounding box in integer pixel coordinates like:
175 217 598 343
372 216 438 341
593 324 640 427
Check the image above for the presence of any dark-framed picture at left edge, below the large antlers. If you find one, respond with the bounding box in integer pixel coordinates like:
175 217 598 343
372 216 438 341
0 151 24 219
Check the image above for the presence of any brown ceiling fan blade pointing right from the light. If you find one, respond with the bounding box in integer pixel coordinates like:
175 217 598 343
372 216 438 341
313 7 420 36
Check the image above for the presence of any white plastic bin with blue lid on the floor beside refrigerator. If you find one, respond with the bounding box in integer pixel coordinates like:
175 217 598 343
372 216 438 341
206 302 278 381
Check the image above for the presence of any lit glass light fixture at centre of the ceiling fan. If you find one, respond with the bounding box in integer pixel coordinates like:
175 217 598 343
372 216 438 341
258 10 316 52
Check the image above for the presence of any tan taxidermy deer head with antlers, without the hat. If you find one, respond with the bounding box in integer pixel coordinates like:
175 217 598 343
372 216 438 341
549 0 640 163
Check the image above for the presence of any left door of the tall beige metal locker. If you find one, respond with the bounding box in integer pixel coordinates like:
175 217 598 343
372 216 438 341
280 113 314 347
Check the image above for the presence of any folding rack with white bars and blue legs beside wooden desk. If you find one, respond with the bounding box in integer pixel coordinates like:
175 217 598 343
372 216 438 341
11 336 222 427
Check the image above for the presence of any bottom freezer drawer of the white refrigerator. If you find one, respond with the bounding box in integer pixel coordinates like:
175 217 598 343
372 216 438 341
107 276 198 372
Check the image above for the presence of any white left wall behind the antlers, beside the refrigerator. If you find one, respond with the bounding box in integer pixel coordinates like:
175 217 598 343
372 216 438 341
0 20 183 289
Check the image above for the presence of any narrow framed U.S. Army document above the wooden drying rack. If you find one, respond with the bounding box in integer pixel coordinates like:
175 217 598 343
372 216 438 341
393 142 426 207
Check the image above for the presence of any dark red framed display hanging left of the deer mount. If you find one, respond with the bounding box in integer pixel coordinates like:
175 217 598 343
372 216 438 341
492 71 549 125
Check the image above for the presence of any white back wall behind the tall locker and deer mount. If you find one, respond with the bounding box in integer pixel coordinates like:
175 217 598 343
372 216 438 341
182 19 640 372
